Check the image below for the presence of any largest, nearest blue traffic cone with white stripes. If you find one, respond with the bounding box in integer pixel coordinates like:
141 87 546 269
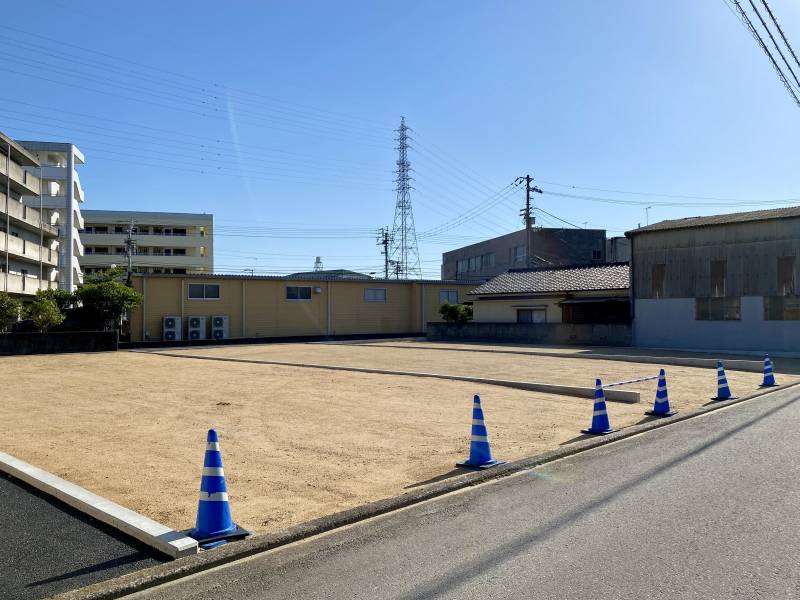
187 429 250 550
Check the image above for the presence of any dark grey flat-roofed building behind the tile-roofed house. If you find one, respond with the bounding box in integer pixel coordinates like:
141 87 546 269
442 227 606 280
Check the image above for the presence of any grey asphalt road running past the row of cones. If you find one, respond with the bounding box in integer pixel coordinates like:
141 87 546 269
137 388 800 600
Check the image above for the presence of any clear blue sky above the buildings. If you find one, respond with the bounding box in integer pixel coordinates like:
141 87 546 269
0 0 800 276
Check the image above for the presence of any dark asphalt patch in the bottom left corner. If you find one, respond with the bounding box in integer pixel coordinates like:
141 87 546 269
0 474 167 600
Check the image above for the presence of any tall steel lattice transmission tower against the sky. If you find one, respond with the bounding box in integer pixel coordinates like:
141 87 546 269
390 117 422 279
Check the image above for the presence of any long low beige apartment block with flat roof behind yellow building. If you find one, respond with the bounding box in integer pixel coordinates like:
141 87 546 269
80 210 214 275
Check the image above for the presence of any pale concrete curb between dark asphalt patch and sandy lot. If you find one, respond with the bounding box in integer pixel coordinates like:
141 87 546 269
0 452 198 558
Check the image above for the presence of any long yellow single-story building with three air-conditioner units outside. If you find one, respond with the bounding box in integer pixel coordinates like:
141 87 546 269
130 274 477 342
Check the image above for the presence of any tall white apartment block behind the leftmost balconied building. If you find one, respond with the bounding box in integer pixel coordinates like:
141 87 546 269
19 141 85 291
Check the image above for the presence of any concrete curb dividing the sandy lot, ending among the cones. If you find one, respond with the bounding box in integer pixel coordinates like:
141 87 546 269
142 350 636 404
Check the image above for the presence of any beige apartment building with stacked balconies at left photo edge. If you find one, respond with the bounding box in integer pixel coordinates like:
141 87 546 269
0 133 59 299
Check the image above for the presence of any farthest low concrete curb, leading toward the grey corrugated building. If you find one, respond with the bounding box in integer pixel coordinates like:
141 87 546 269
354 340 764 373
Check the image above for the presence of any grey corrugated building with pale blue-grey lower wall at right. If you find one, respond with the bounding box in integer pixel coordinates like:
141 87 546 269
626 207 800 353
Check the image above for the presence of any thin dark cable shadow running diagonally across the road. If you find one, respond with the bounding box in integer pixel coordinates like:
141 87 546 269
396 396 800 600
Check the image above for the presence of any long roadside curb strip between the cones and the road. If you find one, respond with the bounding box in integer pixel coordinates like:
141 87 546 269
52 382 800 600
